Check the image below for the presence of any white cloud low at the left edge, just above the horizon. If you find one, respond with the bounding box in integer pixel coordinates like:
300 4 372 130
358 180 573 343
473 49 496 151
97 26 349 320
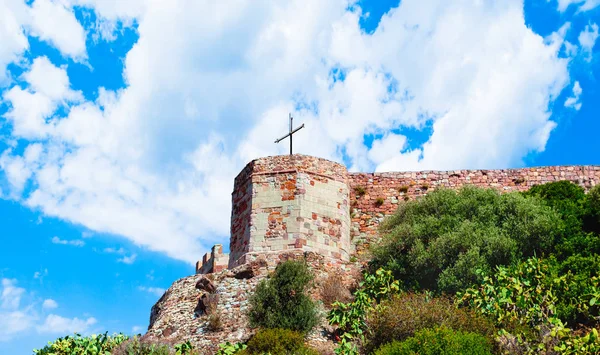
0 278 97 342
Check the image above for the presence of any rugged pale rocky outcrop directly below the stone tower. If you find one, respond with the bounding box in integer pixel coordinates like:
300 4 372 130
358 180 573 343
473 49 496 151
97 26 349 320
147 251 361 354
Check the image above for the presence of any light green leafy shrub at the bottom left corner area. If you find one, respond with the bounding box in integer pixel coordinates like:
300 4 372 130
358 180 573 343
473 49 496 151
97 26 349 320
33 332 129 355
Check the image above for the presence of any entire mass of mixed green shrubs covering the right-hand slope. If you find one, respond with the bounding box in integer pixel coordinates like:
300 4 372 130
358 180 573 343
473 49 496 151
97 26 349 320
329 182 600 354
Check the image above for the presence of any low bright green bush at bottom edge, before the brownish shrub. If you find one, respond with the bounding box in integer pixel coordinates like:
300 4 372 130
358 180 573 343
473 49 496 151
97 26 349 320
375 328 492 355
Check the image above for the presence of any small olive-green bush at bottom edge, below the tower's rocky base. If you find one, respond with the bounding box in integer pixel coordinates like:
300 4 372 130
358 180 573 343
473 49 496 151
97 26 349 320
245 329 317 355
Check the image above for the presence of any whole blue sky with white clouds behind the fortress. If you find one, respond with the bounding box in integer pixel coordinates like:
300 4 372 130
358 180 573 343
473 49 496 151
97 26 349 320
0 0 600 354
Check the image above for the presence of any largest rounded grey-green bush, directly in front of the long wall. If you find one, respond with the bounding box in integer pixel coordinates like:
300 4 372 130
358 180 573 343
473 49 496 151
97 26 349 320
370 187 564 293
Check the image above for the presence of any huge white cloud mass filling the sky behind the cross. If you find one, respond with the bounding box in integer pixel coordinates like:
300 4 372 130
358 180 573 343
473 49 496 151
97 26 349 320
0 0 575 262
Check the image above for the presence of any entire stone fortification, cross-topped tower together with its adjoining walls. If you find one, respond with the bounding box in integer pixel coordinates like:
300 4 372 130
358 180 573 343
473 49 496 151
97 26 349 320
196 154 600 273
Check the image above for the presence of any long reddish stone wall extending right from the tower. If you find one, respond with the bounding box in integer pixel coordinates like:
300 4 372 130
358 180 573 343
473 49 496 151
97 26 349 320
348 166 600 249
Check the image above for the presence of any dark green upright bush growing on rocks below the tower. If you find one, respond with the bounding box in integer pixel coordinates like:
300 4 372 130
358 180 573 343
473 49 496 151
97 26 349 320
248 261 318 333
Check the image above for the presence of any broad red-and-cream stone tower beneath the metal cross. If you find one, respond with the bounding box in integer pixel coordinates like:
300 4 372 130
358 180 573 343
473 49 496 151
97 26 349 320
229 154 353 268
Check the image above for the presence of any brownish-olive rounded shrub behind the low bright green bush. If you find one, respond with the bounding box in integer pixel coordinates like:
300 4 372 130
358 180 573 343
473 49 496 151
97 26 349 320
366 293 496 353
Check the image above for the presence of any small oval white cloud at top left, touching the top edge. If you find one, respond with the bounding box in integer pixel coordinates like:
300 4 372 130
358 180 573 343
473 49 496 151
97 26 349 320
30 0 87 60
